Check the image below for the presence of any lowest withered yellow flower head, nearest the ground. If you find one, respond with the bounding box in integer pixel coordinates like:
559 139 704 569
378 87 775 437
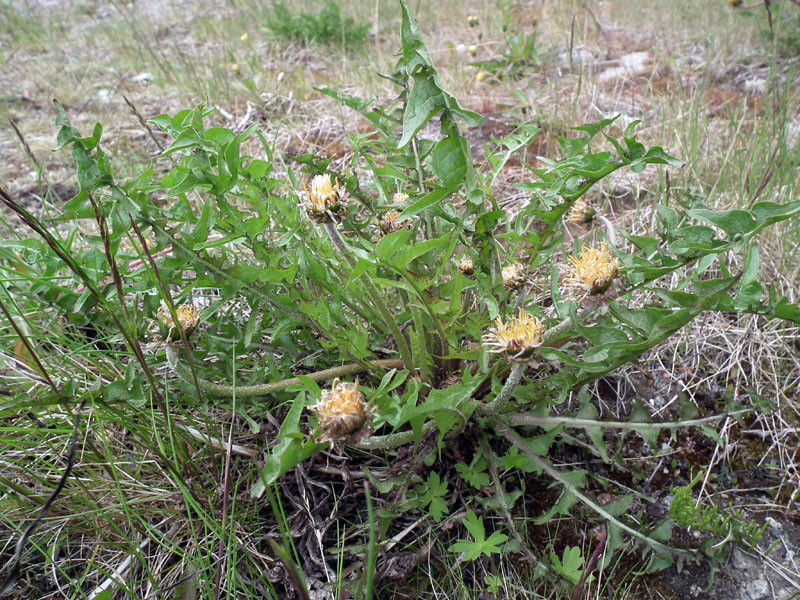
308 379 372 442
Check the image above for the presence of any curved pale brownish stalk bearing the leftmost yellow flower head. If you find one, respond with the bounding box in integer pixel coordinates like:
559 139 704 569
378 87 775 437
166 345 403 398
